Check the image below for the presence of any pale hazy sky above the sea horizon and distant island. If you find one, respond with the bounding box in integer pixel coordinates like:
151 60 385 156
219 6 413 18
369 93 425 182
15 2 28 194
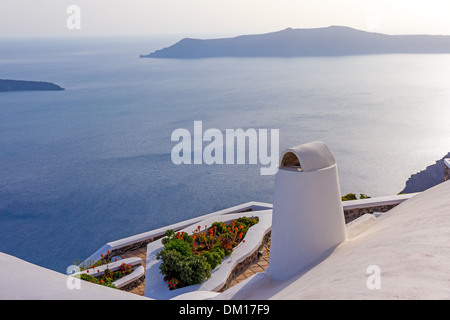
0 0 450 36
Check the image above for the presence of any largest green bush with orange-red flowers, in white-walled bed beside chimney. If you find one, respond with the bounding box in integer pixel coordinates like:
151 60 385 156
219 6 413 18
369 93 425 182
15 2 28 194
156 217 259 290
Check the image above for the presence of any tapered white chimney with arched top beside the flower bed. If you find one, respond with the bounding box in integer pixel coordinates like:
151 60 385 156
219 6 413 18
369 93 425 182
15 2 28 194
268 141 347 280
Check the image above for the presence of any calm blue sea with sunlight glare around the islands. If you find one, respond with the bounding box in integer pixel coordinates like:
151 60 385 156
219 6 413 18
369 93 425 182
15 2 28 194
0 37 450 272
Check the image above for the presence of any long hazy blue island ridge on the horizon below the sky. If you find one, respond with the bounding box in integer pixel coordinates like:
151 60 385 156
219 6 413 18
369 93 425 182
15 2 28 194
141 26 450 59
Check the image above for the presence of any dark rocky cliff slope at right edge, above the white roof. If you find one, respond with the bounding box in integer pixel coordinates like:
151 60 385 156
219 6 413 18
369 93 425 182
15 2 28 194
400 152 450 193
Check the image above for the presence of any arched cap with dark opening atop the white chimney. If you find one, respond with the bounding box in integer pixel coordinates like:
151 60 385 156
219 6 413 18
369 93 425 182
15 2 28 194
280 141 336 171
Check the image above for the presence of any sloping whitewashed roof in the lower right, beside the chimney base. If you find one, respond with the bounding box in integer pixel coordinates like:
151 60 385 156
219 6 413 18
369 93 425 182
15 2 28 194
215 181 450 299
